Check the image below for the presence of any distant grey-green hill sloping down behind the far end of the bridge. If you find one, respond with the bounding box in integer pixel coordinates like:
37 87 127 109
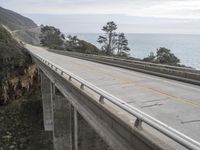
0 7 41 45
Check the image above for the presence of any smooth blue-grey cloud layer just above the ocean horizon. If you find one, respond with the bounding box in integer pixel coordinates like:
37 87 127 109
29 14 200 34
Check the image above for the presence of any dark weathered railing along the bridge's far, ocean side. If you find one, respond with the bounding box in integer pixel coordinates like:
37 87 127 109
48 49 200 85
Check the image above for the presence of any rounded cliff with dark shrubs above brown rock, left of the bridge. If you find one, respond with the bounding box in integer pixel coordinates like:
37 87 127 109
0 26 37 105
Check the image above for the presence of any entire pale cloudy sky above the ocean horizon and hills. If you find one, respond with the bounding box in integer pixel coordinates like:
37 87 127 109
0 0 200 34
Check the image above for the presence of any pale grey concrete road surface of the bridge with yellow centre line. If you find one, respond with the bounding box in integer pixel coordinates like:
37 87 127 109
26 45 200 142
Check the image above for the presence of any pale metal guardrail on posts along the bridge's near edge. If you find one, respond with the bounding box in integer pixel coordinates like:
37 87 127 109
29 51 200 150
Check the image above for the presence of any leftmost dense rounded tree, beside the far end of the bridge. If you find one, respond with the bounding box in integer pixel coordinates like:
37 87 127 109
40 26 65 48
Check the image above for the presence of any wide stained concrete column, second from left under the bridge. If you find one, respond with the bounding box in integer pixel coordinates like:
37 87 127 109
52 84 72 150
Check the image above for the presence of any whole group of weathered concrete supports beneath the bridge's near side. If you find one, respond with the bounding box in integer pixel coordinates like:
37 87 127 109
40 71 108 150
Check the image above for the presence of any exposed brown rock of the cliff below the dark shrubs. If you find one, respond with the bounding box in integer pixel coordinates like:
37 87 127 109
0 64 37 105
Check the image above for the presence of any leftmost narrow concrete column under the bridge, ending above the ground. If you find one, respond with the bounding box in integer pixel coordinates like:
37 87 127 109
40 71 53 131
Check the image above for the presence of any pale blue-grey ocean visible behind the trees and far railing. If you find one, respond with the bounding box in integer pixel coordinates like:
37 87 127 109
72 33 200 70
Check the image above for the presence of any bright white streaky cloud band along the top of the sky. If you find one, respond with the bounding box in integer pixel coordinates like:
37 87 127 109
0 0 200 18
